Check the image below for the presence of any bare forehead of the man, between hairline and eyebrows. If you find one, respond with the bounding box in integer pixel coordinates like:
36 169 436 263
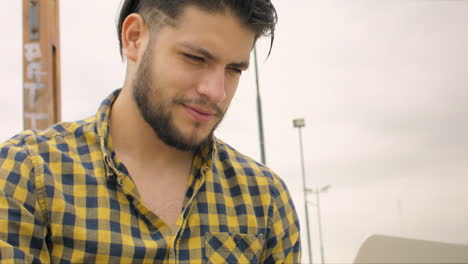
156 6 255 60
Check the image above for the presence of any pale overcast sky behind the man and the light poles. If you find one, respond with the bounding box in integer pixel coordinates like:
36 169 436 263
0 0 468 263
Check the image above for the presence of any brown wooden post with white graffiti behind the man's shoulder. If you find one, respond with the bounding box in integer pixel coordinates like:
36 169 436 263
23 0 61 129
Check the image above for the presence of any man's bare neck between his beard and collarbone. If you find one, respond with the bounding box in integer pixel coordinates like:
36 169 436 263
110 87 194 169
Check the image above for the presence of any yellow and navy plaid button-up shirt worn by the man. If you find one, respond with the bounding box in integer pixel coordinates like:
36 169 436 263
0 90 300 263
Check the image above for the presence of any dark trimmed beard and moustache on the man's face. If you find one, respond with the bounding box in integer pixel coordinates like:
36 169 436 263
132 43 224 152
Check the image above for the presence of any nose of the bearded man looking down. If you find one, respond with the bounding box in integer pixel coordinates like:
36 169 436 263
197 70 226 103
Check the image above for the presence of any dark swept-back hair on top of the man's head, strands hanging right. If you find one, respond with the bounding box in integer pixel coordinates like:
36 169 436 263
117 0 278 56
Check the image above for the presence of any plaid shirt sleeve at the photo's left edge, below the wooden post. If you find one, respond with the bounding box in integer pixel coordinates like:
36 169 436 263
0 145 50 263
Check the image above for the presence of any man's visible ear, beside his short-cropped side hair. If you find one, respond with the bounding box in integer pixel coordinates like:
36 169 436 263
122 13 148 62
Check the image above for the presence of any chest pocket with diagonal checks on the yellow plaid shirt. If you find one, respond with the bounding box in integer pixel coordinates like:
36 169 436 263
205 232 264 264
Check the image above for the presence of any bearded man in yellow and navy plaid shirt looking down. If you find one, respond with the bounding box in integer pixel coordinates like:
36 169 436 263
0 0 300 263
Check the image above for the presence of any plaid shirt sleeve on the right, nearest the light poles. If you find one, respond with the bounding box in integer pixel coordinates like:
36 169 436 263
261 174 301 264
